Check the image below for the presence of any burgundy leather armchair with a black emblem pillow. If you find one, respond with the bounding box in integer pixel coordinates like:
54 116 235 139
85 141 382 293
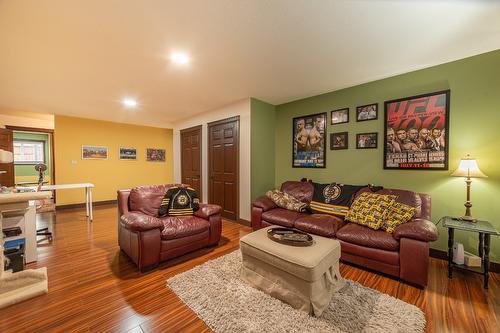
118 184 222 271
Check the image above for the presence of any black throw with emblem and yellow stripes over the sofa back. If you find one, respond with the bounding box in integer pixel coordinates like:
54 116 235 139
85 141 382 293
309 182 383 217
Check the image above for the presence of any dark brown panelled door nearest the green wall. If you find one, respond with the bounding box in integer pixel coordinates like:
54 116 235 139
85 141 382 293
208 117 240 221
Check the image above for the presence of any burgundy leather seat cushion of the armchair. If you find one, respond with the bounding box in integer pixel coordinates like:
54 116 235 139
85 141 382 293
160 216 210 240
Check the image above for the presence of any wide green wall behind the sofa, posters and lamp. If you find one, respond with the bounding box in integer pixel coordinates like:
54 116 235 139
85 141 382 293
274 50 500 262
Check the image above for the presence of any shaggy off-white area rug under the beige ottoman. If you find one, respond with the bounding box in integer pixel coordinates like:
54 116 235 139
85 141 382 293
167 251 426 333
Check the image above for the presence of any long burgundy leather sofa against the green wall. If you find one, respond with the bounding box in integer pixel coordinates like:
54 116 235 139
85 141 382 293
252 181 438 287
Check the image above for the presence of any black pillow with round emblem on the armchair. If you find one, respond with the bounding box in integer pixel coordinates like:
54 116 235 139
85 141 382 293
158 186 200 216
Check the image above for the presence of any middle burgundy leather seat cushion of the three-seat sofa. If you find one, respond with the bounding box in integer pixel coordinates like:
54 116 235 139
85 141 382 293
294 214 346 238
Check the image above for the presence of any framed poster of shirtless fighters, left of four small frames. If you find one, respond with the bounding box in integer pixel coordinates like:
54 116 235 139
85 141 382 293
292 112 326 168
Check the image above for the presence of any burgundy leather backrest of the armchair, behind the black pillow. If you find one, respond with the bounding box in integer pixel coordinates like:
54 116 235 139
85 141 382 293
129 184 186 217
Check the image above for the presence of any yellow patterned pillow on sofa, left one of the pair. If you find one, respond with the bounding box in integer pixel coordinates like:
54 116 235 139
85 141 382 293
345 192 396 230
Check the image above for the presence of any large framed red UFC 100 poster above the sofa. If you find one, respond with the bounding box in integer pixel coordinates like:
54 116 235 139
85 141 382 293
384 90 450 170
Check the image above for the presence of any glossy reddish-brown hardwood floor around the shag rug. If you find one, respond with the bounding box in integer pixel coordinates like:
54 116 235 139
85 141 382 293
0 206 500 333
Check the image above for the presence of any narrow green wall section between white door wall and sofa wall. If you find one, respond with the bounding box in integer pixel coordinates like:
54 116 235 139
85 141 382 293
250 98 276 200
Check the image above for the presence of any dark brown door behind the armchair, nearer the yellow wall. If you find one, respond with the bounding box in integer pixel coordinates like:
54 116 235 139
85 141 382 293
181 125 202 197
